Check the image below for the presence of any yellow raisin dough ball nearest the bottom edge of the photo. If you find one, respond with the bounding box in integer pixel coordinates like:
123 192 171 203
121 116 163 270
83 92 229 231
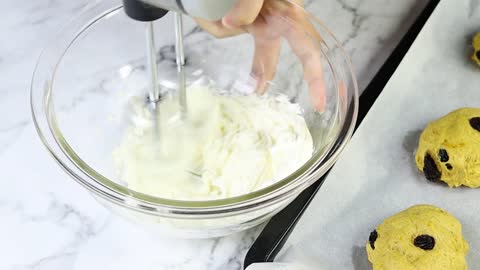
366 205 468 270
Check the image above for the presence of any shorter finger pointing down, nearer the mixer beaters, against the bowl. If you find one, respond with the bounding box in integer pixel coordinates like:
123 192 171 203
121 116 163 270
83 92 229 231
249 16 281 94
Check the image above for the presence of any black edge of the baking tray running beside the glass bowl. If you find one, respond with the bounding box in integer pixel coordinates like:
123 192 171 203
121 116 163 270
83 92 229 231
244 0 440 268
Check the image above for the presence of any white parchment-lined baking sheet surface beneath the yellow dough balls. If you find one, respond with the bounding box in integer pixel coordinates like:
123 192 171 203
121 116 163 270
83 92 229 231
277 0 480 270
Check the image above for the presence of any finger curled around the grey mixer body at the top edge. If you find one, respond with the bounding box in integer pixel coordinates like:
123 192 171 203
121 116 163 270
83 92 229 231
222 0 264 28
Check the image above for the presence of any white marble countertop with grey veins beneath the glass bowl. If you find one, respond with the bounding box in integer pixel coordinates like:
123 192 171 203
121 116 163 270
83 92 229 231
0 0 426 270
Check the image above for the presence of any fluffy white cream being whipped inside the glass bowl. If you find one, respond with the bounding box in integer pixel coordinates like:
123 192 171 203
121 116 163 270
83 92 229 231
114 86 313 200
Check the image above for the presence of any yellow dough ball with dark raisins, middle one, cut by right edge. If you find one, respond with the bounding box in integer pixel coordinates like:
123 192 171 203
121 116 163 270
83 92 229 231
415 108 480 188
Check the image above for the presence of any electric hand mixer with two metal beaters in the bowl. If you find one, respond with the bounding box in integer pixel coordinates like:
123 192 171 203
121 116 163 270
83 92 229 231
123 0 235 178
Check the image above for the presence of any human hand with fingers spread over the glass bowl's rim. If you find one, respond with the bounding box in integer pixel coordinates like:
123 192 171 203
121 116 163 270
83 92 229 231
196 0 326 111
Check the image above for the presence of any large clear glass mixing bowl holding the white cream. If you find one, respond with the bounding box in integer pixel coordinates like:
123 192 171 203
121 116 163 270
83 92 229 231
31 0 358 237
